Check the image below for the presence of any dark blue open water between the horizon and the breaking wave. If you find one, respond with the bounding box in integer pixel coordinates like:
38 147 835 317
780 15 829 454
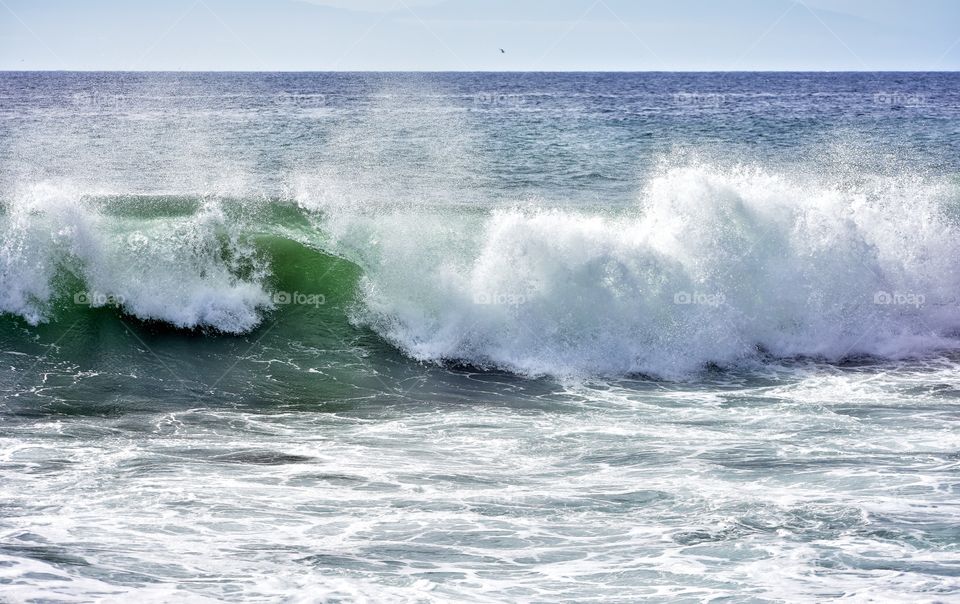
0 73 960 203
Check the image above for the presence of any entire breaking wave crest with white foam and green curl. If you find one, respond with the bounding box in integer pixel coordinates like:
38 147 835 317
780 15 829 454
0 162 960 377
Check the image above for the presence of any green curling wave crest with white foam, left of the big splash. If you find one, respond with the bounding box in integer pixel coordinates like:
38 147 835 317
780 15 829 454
0 187 357 334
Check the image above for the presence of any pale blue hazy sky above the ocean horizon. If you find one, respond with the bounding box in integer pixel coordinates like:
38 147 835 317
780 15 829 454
0 0 960 71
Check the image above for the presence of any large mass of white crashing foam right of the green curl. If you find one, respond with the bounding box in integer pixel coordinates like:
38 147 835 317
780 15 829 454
344 164 960 376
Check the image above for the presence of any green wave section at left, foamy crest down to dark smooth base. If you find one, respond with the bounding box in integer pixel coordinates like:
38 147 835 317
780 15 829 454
0 197 428 415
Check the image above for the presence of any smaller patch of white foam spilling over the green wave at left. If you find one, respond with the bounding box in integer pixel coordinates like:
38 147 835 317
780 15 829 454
0 183 271 333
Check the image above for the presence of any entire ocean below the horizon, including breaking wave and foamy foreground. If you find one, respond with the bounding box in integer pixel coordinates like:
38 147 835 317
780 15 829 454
0 73 960 602
